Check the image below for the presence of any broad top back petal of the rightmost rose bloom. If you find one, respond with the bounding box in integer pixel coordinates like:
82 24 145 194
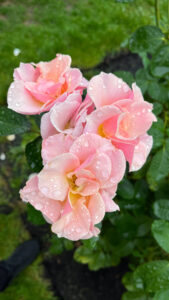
88 72 131 108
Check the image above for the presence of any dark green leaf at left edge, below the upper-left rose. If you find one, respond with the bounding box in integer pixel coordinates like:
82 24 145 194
0 107 30 135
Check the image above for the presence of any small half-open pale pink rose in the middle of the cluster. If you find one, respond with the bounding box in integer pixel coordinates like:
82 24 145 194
41 91 94 139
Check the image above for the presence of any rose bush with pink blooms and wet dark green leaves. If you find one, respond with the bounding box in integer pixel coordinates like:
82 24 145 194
0 26 169 300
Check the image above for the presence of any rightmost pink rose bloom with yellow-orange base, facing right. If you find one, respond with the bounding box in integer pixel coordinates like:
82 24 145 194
84 72 156 171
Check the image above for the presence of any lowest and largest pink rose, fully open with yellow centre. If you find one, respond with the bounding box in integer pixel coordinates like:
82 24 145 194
20 133 126 241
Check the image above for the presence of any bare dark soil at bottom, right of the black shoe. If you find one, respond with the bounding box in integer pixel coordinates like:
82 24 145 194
44 252 128 300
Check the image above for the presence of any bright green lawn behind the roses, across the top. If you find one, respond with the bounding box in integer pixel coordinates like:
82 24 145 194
0 0 167 103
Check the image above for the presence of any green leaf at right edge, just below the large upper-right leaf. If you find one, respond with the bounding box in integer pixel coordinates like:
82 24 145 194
150 45 169 77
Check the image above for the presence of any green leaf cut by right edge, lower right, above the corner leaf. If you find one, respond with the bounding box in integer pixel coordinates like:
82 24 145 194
151 220 169 253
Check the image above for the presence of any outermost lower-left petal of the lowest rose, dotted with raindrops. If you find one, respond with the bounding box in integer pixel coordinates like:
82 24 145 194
20 176 61 223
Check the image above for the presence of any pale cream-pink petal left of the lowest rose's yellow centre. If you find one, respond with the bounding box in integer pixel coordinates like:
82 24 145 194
38 153 79 201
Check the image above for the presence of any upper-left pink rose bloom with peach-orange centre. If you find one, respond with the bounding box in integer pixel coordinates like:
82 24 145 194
7 54 87 115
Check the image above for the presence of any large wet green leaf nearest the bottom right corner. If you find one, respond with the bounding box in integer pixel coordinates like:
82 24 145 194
133 260 169 293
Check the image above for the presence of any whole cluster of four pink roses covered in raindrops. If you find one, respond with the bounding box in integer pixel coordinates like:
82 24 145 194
8 54 156 240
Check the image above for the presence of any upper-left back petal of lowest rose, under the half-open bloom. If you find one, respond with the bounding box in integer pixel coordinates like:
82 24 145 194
42 133 74 164
